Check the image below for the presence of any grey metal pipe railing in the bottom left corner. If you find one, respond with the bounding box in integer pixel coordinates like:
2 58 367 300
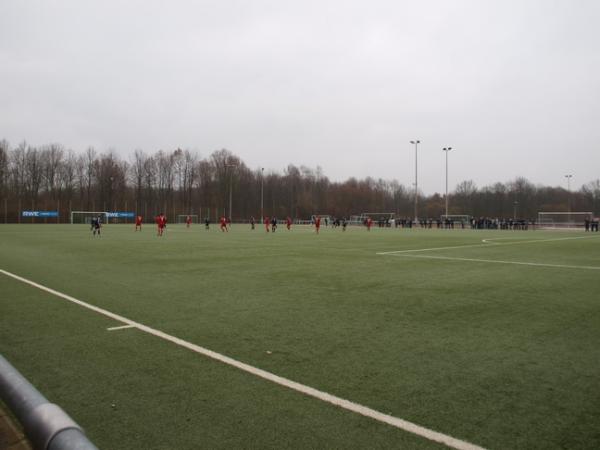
0 355 98 450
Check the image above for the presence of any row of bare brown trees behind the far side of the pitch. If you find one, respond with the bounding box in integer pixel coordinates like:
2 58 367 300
0 140 600 222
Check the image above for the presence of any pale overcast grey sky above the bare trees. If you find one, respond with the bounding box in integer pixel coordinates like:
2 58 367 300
0 0 600 194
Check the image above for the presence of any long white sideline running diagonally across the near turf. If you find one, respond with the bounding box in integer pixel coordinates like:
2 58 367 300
0 269 484 450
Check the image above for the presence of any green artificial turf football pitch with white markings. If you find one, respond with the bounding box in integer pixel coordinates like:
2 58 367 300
0 225 600 449
